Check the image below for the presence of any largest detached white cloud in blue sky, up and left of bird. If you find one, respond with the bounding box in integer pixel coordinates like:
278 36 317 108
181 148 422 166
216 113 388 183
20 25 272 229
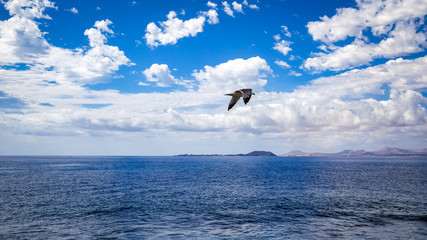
145 10 209 47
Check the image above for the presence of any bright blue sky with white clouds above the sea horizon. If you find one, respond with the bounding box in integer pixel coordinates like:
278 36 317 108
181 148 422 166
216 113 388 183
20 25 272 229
0 0 427 155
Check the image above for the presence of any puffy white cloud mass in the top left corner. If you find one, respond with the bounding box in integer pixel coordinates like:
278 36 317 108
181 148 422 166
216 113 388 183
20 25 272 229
0 1 131 84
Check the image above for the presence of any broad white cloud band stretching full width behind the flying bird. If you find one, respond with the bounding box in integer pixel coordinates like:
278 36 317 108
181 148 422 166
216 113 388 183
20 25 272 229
0 53 427 153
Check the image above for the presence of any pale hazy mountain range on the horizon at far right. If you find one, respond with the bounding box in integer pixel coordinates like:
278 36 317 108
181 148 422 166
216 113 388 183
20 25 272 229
281 147 427 157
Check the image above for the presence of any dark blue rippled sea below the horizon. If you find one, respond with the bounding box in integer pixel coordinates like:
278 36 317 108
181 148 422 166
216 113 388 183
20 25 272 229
0 157 427 239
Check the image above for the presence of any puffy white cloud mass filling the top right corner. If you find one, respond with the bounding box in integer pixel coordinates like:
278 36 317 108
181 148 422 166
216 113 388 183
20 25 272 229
304 0 427 71
